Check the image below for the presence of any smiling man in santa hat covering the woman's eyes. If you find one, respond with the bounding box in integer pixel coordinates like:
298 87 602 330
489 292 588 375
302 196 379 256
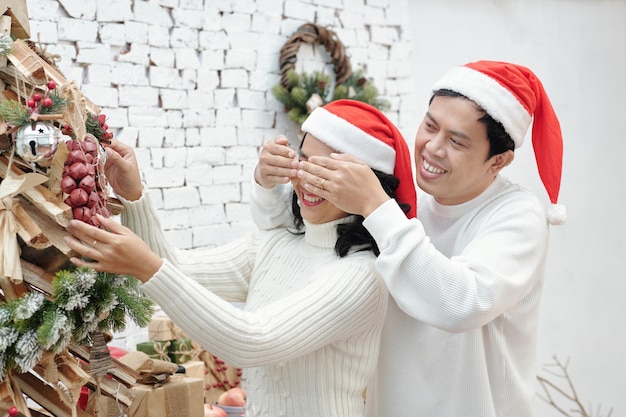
252 61 565 417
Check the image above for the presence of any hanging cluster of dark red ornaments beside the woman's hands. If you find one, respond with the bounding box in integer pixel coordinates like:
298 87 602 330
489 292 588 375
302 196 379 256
61 137 111 227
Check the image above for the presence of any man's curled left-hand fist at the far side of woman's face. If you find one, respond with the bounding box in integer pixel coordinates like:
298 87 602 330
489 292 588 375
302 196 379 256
254 135 298 188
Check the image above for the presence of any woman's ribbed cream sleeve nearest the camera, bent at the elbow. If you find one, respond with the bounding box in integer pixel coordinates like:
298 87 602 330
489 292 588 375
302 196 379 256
143 254 387 367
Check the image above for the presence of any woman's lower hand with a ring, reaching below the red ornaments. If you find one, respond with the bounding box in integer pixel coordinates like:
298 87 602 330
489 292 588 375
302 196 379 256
65 215 163 282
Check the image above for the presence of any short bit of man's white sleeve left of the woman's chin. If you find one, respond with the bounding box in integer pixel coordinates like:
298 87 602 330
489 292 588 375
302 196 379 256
250 175 293 230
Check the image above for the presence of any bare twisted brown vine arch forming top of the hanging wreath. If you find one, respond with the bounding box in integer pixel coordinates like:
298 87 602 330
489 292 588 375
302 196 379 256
279 23 352 89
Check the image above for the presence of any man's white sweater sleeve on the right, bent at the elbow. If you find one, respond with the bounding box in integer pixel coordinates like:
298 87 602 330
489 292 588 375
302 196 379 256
364 200 547 332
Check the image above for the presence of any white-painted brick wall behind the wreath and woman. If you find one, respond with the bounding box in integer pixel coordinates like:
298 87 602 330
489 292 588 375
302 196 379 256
27 0 416 348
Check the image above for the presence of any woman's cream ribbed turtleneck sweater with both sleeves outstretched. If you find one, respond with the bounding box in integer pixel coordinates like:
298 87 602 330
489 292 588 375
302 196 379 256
122 192 388 417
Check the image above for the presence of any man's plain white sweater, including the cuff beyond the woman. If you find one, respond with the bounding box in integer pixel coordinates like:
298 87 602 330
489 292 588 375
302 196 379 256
252 177 548 417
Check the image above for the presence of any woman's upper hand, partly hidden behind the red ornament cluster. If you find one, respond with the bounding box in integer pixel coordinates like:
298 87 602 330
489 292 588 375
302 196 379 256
103 140 143 201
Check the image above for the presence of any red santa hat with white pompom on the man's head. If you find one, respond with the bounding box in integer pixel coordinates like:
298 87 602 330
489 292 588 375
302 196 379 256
433 61 567 224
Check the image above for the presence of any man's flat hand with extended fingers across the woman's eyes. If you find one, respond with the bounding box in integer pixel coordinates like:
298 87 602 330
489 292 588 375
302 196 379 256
297 153 390 217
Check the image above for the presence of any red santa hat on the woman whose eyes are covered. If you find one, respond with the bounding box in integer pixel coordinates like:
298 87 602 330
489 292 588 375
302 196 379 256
302 99 417 218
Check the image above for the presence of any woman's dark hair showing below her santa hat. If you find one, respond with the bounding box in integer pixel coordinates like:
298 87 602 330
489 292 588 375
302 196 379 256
291 169 411 257
